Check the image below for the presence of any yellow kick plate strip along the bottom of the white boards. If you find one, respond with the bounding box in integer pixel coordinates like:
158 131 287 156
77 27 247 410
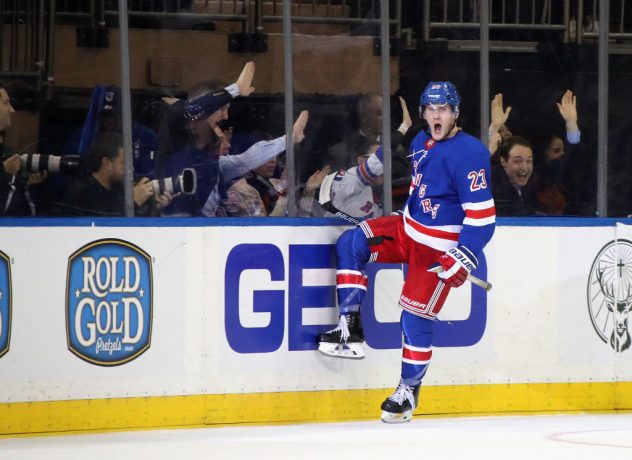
0 382 632 436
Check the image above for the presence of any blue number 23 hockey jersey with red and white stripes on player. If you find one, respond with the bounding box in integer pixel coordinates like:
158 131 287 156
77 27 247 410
403 131 496 255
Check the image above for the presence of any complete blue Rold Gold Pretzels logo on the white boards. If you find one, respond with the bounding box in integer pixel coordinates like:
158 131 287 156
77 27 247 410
66 239 153 366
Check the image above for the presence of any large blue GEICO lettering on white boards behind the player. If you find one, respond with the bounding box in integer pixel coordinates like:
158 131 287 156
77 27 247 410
224 242 487 354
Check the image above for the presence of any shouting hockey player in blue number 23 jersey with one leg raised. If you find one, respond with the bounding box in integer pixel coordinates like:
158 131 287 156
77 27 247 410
319 82 496 423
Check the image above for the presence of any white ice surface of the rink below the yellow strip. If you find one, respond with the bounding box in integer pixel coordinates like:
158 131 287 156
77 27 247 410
0 413 632 460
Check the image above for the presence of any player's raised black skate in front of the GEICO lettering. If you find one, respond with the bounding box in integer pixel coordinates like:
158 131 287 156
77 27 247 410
318 312 365 359
